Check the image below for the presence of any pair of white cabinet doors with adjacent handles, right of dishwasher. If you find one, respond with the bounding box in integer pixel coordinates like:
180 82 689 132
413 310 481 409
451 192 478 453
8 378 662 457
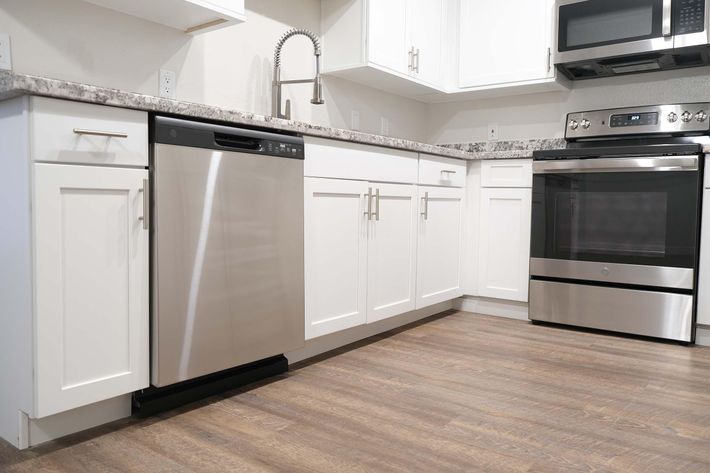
305 178 418 339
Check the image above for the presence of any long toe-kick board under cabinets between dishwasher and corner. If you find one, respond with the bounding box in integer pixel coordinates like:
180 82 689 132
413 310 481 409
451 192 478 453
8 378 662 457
286 301 452 364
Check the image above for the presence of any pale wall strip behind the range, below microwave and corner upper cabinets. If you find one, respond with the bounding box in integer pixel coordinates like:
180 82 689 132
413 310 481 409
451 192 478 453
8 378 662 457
427 67 710 144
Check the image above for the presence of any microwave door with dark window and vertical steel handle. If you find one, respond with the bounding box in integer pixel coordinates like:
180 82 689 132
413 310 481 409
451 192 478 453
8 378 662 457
555 0 676 64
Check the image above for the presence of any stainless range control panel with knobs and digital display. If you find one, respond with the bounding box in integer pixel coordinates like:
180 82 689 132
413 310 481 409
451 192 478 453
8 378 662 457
565 103 710 141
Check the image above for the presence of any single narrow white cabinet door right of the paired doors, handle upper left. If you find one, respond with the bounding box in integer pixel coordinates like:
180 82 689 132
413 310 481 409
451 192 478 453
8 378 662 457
417 186 464 309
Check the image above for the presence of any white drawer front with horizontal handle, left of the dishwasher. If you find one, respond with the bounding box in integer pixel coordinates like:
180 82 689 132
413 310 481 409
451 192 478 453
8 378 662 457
30 97 148 166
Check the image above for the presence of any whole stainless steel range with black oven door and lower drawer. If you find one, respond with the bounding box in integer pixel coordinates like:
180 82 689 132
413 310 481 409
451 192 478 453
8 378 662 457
530 103 710 342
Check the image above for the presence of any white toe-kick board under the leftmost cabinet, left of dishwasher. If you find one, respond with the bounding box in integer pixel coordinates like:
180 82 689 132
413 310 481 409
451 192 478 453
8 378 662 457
19 394 131 448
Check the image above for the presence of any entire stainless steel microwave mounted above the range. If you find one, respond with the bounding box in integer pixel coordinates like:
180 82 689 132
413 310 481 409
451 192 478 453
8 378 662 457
554 0 710 80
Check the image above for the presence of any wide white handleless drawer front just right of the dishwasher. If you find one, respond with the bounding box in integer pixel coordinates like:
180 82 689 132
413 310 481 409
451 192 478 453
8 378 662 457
304 136 417 184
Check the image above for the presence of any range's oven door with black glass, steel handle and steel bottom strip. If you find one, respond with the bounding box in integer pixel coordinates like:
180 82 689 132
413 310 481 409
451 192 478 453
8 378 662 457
530 155 701 290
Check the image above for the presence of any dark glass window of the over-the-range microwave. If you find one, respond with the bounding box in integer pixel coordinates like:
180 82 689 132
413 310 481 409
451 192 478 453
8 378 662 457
558 0 663 51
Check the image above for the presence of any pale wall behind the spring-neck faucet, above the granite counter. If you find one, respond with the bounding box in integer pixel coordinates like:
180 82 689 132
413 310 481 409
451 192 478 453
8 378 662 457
0 0 427 140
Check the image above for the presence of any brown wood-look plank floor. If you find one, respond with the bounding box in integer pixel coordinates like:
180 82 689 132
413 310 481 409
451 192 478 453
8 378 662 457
0 312 710 473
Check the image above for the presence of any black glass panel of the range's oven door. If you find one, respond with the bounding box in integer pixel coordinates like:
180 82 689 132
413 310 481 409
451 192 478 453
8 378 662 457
531 171 699 268
